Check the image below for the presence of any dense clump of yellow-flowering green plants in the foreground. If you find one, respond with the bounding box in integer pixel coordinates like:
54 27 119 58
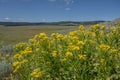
11 24 120 80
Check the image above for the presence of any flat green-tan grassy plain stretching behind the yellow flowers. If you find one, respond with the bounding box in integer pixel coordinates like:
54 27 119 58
0 25 77 48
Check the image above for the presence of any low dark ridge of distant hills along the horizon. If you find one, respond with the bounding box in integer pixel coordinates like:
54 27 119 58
0 20 106 26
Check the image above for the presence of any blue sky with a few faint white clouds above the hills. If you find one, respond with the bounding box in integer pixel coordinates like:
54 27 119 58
0 0 120 22
